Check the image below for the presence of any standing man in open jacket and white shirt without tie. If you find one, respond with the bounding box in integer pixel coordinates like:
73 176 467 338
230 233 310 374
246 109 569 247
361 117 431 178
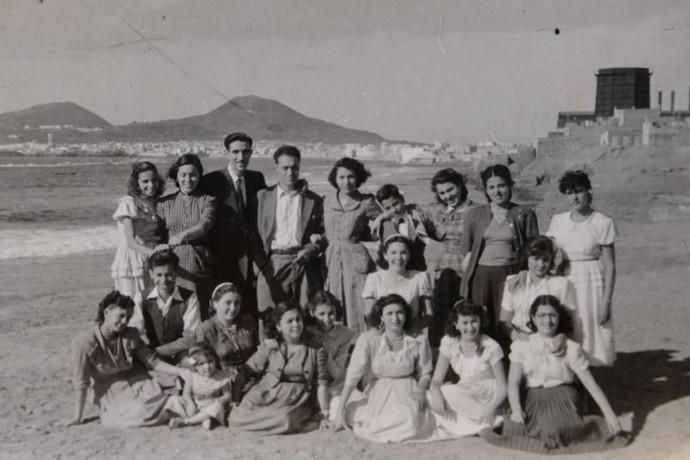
254 145 326 312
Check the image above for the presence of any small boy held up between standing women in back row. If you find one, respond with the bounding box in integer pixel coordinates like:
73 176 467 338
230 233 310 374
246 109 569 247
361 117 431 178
371 184 431 271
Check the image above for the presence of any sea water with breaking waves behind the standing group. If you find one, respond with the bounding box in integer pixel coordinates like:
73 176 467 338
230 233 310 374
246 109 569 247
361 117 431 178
0 157 462 260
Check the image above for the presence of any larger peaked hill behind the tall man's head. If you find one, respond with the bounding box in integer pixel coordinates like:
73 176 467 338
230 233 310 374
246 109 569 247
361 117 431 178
121 96 385 144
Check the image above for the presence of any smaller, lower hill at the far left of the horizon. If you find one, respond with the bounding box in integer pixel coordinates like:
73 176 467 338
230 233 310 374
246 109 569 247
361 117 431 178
0 102 112 130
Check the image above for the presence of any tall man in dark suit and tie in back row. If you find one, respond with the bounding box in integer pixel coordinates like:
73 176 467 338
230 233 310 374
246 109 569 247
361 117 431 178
201 133 266 318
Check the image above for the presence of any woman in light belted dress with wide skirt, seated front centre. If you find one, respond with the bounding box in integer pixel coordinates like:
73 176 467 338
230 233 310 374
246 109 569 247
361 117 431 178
335 294 438 442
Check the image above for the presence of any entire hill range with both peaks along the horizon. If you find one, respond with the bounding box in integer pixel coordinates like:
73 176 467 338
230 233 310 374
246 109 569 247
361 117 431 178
0 96 385 144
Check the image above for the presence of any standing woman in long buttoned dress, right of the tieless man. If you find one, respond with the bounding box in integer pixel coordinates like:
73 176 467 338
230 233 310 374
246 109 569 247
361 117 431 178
324 158 379 332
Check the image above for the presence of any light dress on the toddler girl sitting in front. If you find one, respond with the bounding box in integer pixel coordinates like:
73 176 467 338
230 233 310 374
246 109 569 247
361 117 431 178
167 370 234 425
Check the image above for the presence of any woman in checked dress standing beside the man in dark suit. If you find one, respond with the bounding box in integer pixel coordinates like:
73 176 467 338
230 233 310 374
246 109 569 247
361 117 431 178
157 153 216 320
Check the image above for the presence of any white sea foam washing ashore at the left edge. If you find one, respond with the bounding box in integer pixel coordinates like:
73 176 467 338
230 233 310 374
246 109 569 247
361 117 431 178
0 225 118 260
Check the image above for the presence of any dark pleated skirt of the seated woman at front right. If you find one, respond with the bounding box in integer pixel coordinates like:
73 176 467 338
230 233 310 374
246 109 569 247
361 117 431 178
480 385 627 454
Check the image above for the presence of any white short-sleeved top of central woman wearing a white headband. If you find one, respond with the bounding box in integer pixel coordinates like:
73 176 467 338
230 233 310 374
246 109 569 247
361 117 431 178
362 270 431 332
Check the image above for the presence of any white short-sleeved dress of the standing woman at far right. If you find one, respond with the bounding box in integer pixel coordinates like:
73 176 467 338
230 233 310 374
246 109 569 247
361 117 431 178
546 211 616 366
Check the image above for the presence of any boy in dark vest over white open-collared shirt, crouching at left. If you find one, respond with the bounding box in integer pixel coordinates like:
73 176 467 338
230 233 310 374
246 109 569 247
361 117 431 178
129 249 201 363
